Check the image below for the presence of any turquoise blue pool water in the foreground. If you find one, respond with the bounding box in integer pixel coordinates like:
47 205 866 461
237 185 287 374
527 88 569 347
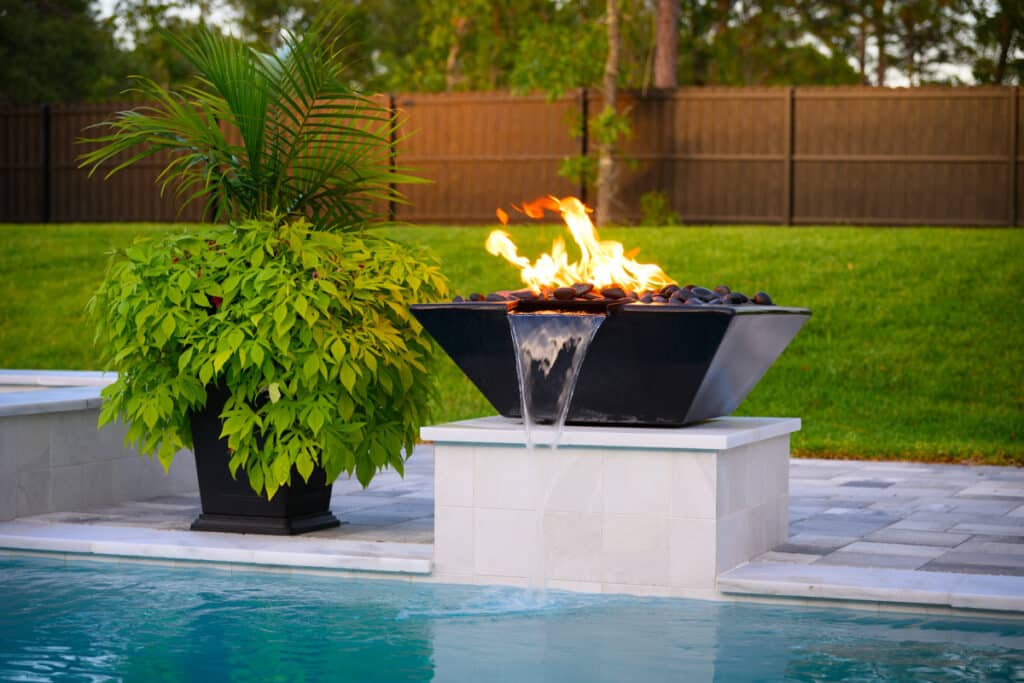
0 556 1024 683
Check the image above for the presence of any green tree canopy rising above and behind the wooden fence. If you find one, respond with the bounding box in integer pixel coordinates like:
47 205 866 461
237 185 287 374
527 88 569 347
0 0 1024 103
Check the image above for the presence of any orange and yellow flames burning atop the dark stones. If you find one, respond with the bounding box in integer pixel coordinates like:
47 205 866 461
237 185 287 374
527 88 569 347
484 197 676 293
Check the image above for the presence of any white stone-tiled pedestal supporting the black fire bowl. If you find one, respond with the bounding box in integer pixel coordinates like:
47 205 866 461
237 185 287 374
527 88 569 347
421 417 800 596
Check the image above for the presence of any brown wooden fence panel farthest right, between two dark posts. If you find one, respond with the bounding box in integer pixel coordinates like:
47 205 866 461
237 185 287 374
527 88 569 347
794 88 1012 225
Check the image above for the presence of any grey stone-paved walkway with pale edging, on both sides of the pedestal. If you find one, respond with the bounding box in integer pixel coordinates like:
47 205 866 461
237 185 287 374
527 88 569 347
0 445 1024 612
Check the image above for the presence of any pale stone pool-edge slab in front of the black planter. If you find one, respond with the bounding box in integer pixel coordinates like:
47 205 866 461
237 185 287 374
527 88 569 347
0 519 433 574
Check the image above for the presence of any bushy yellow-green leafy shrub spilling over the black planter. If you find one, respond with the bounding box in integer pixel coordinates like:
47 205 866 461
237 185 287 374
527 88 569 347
89 219 446 498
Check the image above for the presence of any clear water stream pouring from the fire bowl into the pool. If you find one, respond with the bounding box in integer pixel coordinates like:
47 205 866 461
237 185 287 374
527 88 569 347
509 312 604 592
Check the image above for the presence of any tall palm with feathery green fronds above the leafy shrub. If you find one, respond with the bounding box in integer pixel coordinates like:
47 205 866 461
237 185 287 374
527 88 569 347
80 18 417 230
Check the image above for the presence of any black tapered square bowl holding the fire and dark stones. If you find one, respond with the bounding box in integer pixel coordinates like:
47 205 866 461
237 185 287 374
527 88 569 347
411 302 811 427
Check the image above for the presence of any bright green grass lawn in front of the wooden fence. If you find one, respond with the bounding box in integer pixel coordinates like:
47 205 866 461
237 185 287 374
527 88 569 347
0 224 1024 465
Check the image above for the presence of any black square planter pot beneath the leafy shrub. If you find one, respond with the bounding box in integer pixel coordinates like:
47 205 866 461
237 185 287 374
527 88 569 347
191 387 341 536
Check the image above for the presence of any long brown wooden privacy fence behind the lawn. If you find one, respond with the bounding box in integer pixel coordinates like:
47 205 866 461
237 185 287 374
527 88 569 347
0 87 1024 225
